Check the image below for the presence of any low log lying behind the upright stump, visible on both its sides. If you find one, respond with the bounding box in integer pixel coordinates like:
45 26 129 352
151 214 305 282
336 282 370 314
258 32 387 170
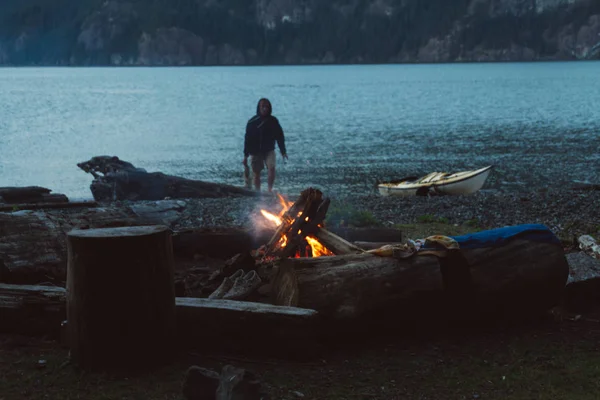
0 284 326 357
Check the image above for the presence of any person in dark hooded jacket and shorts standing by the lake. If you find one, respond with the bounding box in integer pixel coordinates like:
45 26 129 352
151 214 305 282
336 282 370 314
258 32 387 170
242 98 288 192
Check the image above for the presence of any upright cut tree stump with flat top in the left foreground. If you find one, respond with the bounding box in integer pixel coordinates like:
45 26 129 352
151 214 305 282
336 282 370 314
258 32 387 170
67 225 175 371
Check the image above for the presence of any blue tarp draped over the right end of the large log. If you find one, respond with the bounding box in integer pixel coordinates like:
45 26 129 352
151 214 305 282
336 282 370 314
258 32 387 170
450 224 560 249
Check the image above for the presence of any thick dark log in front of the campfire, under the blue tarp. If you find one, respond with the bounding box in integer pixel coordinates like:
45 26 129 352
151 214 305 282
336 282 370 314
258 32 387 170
271 239 569 319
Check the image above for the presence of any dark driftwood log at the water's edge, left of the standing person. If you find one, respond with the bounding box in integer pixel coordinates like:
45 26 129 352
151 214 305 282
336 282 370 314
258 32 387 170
77 156 264 202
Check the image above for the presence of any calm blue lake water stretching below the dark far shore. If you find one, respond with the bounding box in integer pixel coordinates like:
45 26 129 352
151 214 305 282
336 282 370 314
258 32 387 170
0 62 600 199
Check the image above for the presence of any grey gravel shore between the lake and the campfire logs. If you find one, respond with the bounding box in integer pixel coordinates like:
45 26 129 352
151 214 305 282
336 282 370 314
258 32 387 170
170 188 600 238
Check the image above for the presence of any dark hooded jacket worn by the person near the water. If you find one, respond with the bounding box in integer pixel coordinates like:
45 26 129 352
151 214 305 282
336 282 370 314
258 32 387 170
244 99 286 157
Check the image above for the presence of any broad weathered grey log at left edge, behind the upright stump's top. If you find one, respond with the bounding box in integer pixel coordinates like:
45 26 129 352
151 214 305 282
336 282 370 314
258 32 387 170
0 200 185 284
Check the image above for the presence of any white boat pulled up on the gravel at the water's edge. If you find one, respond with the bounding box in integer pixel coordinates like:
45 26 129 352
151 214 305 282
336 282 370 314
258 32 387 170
377 165 493 197
